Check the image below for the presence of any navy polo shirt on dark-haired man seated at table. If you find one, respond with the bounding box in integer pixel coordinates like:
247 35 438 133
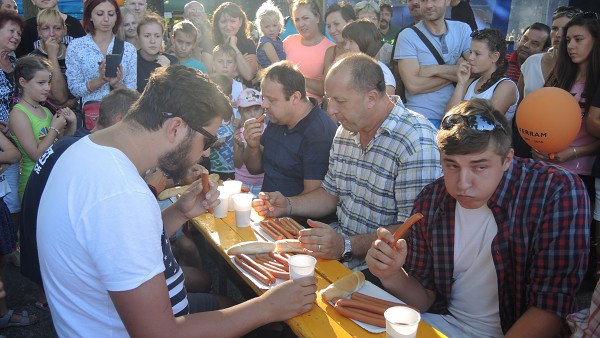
260 99 337 196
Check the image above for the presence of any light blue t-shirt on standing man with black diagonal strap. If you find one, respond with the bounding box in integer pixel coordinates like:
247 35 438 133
393 20 471 120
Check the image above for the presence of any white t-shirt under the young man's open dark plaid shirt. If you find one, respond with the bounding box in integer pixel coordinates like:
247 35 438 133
448 203 504 337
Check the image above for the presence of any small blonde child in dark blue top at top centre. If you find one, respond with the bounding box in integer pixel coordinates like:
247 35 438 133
256 0 285 68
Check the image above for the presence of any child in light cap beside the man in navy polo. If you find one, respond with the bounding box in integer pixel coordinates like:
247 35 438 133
233 88 267 197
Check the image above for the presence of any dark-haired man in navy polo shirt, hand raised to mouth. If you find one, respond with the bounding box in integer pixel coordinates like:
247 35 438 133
244 61 336 196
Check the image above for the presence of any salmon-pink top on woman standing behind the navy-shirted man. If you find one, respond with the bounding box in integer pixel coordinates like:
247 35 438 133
283 34 335 104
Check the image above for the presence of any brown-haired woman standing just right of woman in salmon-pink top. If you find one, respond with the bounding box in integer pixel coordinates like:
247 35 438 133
323 1 356 75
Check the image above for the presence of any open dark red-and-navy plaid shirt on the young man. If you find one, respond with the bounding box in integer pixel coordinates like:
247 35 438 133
405 157 591 333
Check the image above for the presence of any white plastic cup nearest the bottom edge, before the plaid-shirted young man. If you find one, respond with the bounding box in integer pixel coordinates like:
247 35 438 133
383 306 421 338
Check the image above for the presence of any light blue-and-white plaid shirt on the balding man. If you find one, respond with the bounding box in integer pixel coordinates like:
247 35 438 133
322 105 442 269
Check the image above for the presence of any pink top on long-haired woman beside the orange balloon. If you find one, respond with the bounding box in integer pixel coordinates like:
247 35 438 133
560 82 597 176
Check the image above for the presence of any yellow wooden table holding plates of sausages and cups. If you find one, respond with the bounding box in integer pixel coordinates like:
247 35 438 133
192 211 444 338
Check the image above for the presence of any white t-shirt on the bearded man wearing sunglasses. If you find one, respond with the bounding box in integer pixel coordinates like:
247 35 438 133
37 137 164 337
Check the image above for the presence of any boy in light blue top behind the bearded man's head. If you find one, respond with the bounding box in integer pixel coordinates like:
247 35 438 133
171 20 208 74
